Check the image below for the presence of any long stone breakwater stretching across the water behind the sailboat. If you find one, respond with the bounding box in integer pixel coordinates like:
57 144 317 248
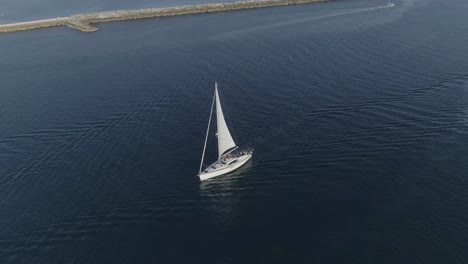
0 0 330 33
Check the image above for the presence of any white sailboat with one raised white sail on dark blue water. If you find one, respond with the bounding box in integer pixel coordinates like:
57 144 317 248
198 83 253 181
